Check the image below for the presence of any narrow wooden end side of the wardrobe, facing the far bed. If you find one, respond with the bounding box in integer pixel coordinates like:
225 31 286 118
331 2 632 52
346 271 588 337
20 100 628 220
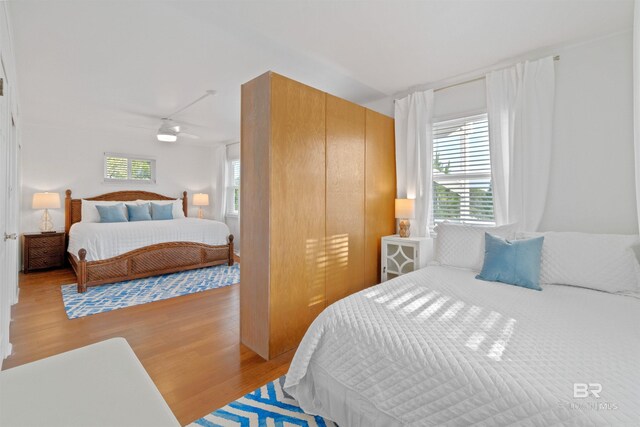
240 73 271 359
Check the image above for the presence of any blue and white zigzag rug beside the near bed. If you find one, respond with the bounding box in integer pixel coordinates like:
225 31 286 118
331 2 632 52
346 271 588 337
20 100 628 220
188 376 338 427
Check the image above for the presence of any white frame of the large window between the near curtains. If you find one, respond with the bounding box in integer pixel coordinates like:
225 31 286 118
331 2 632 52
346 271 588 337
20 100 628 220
429 113 496 230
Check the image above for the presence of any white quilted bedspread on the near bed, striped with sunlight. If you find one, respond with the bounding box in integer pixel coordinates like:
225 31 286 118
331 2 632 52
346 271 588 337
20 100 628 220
285 267 640 427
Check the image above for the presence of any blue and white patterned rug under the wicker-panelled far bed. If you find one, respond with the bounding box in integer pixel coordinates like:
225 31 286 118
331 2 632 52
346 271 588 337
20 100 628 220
62 263 240 319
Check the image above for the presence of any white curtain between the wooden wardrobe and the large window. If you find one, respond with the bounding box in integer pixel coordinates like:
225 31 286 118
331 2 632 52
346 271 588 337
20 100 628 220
395 90 433 237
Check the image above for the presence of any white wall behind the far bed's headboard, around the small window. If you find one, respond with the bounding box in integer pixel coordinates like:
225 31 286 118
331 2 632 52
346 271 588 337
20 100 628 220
21 125 212 232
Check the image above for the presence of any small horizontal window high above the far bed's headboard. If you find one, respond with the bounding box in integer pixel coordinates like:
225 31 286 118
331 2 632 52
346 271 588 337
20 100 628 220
104 153 156 184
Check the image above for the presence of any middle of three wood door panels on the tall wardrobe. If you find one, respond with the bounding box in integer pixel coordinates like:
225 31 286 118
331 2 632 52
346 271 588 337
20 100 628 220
326 95 365 305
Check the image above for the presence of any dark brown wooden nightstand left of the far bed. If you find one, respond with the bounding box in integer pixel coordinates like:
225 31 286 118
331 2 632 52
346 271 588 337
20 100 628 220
22 232 65 273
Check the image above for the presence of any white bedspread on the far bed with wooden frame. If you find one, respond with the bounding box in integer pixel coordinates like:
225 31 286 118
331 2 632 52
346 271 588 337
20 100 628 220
68 218 229 261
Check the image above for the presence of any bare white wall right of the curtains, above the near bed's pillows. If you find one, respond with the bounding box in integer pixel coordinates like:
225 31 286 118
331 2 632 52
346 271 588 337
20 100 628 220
541 32 638 233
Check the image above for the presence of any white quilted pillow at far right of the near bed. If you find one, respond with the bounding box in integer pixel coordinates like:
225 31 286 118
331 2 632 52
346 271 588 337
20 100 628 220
517 231 640 293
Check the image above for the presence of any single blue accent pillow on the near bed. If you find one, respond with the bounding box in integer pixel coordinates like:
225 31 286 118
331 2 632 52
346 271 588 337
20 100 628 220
476 233 544 291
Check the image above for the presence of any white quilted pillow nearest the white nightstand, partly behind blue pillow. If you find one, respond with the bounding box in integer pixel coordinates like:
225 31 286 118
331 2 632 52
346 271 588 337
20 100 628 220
434 222 516 271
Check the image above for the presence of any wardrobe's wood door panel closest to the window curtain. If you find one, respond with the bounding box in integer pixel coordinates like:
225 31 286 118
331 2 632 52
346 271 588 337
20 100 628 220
365 110 396 286
